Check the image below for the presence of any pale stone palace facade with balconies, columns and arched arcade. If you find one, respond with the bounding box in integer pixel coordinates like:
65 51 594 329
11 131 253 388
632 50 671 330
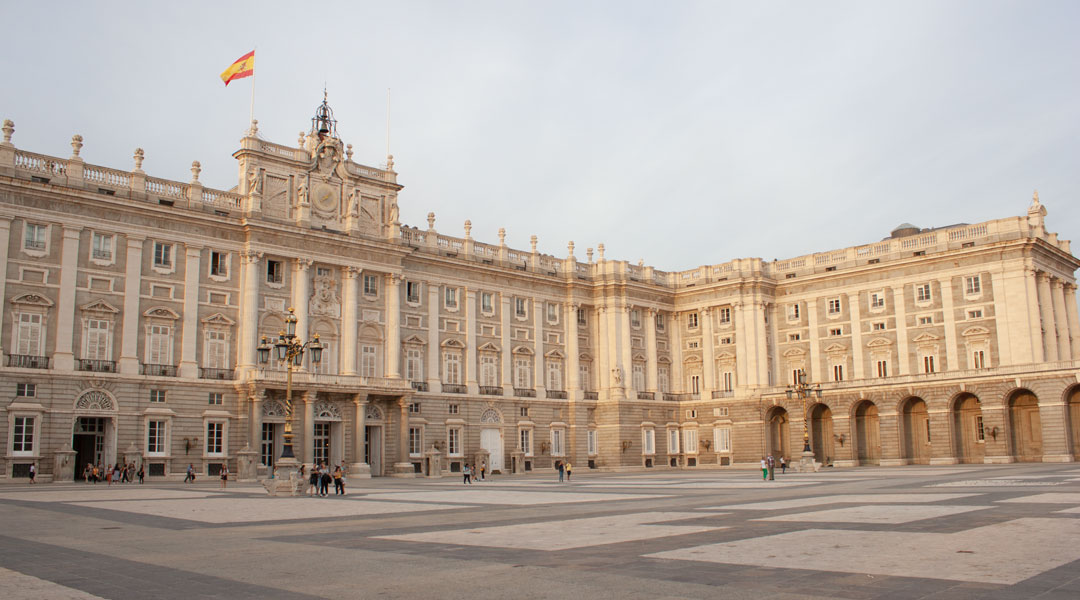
0 103 1080 480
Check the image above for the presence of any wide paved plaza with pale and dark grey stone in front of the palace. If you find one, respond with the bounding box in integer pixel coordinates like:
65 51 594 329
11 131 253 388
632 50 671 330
0 464 1080 599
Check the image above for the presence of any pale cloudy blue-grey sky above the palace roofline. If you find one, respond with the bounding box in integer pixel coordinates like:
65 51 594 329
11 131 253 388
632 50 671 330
0 0 1080 271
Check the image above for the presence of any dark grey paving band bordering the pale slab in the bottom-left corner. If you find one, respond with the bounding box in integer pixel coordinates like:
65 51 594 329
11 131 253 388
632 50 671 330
0 535 319 600
